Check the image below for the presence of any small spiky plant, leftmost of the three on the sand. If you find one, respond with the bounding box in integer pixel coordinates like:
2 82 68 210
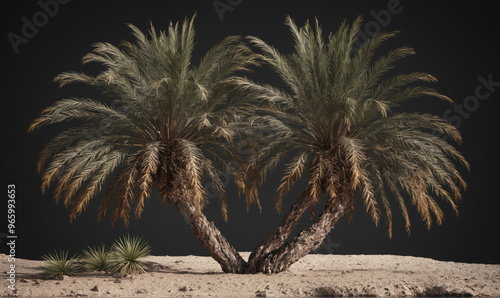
42 250 78 277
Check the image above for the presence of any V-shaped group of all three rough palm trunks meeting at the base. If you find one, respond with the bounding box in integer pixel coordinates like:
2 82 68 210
177 189 348 273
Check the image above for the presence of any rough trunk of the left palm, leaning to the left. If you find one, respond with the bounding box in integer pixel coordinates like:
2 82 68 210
174 199 247 273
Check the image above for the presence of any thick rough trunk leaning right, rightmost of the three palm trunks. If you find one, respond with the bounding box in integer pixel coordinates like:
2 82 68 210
250 192 347 273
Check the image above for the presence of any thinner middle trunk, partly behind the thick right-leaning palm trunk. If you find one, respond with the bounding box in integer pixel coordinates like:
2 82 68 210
247 195 310 273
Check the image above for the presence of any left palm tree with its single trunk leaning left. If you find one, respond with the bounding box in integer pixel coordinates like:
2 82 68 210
29 16 259 272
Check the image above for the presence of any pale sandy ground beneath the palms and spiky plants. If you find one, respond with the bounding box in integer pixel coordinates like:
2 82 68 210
0 253 500 297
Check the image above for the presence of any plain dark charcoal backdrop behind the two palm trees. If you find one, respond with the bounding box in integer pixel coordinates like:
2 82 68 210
0 0 500 264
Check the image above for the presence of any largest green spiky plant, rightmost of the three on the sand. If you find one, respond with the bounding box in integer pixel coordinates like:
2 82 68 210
110 235 151 275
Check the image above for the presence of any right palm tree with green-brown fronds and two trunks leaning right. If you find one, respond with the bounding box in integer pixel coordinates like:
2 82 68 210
241 17 468 272
